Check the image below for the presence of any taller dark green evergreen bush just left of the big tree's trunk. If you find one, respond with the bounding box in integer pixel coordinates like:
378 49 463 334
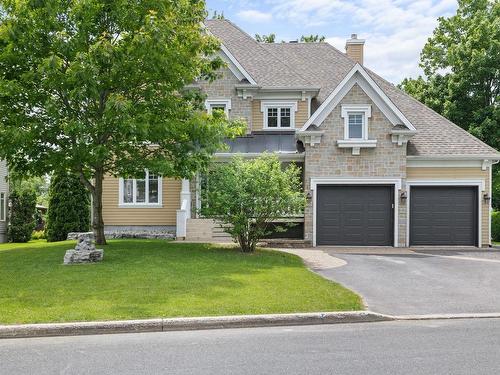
46 174 90 242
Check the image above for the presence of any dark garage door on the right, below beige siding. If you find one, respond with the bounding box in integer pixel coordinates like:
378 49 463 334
410 186 478 246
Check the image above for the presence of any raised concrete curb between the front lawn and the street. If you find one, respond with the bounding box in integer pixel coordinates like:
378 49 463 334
0 311 394 339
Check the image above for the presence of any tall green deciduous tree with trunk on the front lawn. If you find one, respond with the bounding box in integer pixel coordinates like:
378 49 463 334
0 0 239 244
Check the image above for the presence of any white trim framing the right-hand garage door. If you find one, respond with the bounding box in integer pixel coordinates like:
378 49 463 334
406 180 485 247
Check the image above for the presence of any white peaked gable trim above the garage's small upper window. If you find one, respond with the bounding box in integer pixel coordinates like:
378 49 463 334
301 64 416 131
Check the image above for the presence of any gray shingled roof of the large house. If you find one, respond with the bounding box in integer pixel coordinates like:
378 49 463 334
206 20 499 157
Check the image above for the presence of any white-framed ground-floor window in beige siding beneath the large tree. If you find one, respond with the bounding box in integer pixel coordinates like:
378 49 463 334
120 170 162 207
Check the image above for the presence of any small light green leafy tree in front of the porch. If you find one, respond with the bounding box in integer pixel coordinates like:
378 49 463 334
202 155 305 252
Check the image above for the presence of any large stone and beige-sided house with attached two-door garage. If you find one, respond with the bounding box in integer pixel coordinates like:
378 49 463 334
104 20 500 247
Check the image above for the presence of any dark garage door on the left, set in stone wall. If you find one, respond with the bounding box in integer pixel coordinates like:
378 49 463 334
316 185 394 246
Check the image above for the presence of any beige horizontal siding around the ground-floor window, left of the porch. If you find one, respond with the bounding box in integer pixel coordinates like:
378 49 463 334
102 177 181 225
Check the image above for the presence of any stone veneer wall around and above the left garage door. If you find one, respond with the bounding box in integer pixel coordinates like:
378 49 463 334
304 85 406 246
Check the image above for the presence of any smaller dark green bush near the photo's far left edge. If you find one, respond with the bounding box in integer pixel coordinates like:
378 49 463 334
7 190 36 242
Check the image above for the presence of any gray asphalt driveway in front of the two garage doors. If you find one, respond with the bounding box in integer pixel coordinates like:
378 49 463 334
317 249 500 315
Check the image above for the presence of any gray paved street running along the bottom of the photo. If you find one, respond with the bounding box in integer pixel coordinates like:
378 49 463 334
0 319 500 375
